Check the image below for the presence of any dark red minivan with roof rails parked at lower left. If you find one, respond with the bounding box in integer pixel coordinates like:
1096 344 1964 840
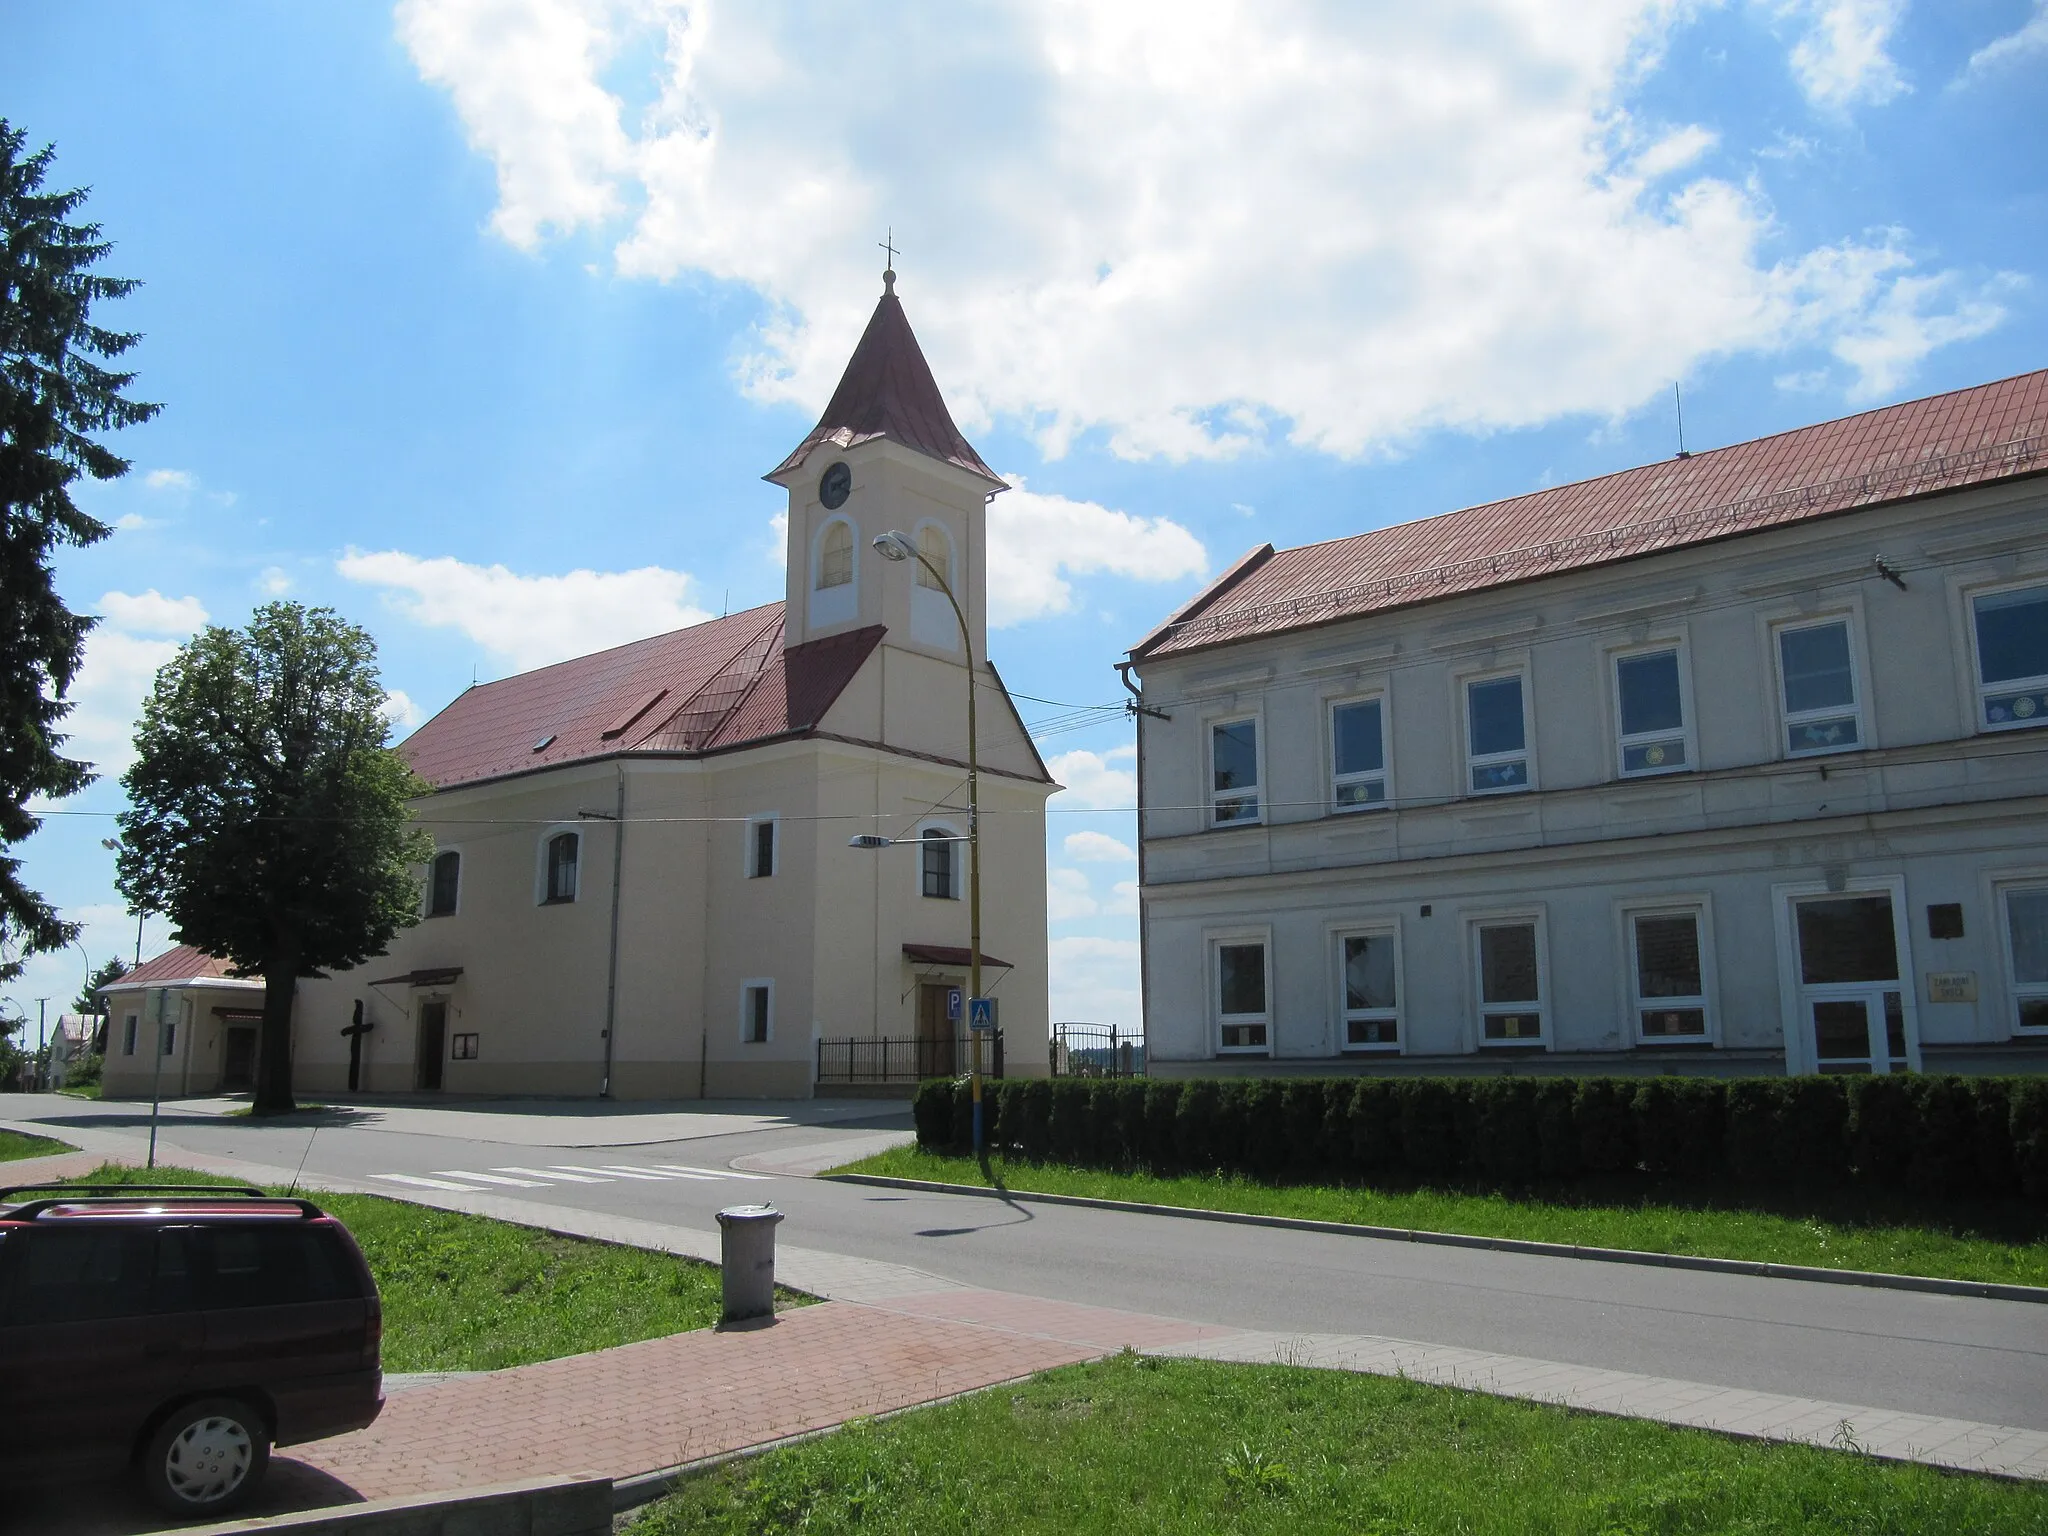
0 1184 383 1518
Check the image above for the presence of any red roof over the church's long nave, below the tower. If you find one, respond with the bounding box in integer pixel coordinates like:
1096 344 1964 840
399 602 883 788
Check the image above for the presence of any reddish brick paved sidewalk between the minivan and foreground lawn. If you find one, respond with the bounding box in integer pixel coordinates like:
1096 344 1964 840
296 1290 1231 1499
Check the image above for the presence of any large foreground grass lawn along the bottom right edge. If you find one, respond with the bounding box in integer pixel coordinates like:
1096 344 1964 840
629 1356 2048 1536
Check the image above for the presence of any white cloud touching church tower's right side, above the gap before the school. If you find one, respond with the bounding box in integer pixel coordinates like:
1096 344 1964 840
989 475 1208 629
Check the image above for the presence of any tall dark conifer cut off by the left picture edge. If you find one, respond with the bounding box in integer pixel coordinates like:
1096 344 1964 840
0 117 160 981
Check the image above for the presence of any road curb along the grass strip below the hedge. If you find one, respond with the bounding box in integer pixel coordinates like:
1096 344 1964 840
821 1174 2048 1305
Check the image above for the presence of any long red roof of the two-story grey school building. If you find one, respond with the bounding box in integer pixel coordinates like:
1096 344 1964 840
1130 369 2048 657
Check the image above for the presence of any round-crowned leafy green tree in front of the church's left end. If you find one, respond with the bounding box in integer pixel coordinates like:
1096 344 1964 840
117 602 434 1114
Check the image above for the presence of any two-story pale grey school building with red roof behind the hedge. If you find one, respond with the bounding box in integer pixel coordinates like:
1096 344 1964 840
1126 371 2048 1075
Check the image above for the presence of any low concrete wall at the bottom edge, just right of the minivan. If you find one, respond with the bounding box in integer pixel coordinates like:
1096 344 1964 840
178 1473 612 1536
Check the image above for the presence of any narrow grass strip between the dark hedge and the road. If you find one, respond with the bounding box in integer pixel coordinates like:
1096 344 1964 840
836 1147 2048 1286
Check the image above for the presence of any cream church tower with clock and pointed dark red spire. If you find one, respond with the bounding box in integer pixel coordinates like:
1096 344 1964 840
766 270 1008 662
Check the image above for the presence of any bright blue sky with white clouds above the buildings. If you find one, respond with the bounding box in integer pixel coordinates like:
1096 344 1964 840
0 0 2048 1034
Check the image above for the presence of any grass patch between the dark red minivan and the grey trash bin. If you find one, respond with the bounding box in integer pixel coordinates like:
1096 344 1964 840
51 1167 809 1370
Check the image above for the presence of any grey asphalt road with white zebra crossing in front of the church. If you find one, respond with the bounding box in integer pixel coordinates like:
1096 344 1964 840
0 1098 2048 1430
